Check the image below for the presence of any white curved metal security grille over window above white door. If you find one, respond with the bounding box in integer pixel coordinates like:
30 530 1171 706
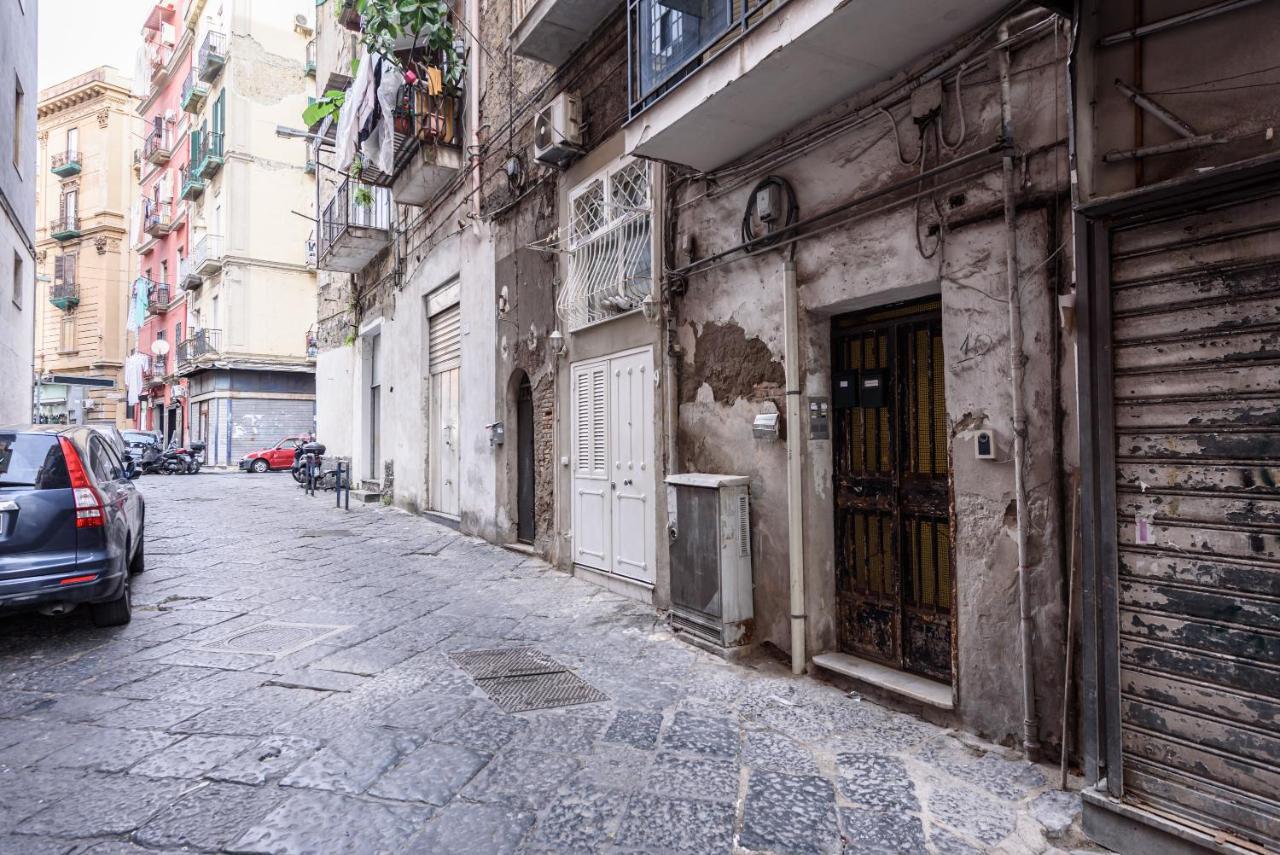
544 160 653 329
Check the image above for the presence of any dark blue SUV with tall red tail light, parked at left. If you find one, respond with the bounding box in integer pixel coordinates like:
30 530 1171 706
0 425 146 626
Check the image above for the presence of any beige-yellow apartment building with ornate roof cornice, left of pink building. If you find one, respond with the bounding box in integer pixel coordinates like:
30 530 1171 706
33 67 141 428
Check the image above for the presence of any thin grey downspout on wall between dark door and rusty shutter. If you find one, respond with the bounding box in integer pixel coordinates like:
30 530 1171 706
1000 23 1039 759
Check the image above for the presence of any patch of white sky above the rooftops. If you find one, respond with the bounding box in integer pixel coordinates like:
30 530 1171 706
37 0 155 88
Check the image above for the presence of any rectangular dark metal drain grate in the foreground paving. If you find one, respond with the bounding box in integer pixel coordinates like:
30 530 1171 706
449 648 609 713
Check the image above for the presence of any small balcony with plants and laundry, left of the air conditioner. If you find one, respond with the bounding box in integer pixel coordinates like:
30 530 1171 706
384 79 465 206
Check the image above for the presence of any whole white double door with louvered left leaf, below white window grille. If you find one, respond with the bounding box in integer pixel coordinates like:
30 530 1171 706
571 348 655 584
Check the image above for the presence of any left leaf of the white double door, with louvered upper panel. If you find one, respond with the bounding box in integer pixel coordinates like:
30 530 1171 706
571 362 612 571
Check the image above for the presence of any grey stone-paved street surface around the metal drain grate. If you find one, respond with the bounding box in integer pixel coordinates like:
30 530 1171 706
0 475 1079 855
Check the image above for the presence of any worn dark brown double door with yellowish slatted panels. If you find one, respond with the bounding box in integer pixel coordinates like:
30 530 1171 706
832 298 952 681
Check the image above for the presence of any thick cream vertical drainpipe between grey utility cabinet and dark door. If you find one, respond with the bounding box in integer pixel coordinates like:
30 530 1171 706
782 255 806 675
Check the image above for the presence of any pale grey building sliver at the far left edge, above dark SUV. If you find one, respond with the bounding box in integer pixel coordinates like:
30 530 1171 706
0 0 37 422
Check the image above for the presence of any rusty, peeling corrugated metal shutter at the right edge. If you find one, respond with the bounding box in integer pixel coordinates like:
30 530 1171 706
1111 186 1280 847
